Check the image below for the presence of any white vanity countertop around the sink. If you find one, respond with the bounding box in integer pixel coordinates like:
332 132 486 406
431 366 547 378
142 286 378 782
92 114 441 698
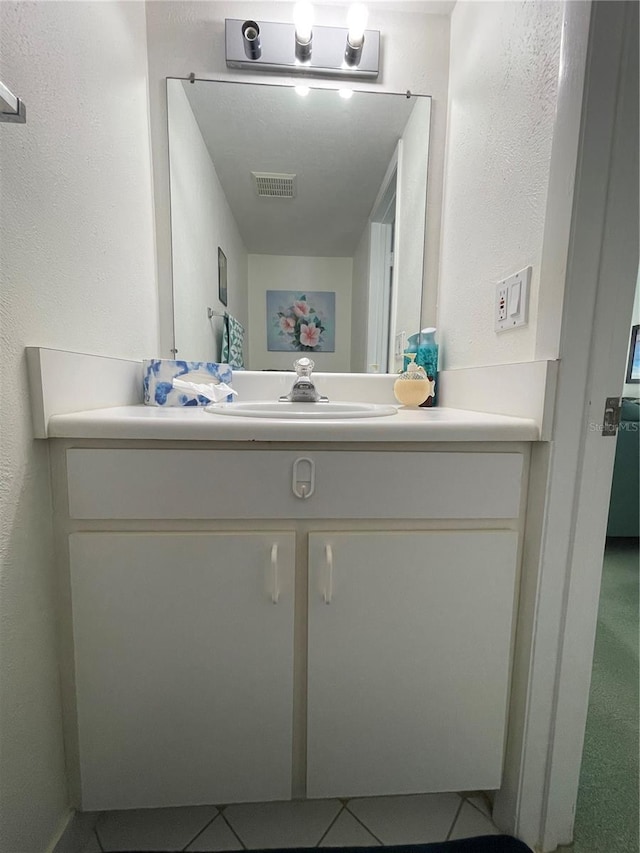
47 405 540 442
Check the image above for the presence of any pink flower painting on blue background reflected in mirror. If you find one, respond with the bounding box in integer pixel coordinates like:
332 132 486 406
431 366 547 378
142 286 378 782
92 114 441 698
267 290 336 352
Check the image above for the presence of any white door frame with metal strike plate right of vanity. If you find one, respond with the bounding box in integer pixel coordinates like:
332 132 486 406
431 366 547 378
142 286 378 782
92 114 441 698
494 0 638 851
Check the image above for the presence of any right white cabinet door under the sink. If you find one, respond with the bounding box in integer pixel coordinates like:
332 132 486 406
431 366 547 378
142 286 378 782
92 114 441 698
307 531 517 797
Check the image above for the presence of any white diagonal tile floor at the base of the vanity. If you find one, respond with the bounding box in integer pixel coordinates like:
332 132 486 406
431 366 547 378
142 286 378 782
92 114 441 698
82 794 499 853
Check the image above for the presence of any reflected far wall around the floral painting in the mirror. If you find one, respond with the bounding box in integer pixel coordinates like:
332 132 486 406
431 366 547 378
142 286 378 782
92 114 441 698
249 255 353 373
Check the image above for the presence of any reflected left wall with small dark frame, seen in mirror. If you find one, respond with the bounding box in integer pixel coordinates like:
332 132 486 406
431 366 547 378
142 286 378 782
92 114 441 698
167 80 248 361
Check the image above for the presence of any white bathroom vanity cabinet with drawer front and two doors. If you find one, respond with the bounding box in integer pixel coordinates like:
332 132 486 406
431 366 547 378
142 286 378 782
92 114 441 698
53 440 528 810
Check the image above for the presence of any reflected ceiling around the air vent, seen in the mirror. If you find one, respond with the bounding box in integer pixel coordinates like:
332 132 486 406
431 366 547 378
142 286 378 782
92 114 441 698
182 81 428 257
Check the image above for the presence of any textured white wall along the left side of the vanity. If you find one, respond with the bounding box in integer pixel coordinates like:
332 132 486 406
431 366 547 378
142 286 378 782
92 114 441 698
0 2 158 853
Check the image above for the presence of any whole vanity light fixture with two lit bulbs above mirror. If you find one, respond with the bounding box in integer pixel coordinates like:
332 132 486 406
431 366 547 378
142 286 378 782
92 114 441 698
225 5 380 79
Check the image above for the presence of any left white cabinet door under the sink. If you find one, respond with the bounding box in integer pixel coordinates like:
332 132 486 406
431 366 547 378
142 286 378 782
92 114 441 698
70 532 295 810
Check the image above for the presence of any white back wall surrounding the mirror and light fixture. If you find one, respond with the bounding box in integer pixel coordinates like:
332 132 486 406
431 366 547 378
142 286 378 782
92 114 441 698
147 0 449 362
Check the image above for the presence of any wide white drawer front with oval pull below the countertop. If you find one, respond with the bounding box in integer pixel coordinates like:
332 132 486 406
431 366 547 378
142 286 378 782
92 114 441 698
67 448 523 519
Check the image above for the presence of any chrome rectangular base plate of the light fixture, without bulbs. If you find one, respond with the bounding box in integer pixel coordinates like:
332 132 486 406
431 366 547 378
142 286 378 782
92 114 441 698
225 18 380 80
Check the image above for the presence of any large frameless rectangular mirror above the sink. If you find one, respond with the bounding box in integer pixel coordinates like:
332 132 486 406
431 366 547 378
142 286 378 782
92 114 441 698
167 79 431 373
